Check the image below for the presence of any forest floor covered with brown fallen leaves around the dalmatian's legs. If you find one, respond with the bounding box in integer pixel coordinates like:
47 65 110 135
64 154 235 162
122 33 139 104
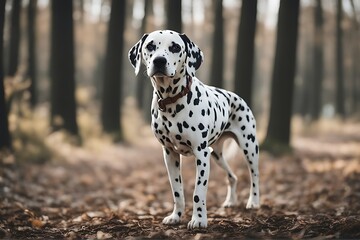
0 116 360 239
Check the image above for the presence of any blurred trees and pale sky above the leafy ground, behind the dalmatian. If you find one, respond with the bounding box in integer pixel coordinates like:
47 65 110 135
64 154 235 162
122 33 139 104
1 0 360 156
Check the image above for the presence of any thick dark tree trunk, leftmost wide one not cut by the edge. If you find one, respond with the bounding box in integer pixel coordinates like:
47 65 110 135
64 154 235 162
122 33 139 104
50 0 78 135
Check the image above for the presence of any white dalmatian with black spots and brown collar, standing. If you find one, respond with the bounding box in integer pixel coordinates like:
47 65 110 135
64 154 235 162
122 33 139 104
129 30 260 229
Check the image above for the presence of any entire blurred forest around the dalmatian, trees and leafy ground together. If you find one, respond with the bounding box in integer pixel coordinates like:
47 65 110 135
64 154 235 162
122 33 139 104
0 0 360 239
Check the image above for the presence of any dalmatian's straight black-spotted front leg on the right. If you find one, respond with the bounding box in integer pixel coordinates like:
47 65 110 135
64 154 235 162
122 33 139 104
188 147 210 229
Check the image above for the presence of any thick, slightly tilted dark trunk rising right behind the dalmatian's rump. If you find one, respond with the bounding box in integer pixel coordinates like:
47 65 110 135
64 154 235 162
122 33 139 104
234 0 257 107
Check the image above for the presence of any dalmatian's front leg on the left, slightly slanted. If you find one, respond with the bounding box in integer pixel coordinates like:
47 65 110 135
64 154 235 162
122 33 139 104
163 147 185 225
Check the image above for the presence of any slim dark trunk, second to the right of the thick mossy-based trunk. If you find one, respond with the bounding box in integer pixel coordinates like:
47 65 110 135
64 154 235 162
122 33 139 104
335 0 345 117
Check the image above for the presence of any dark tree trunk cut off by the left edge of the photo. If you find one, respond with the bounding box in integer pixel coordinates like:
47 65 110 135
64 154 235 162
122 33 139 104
0 0 11 150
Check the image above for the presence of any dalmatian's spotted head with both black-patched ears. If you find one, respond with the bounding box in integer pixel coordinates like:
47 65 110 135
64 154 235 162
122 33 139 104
129 30 204 78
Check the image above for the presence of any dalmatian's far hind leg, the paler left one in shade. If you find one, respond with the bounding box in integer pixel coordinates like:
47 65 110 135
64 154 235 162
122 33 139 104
211 136 238 207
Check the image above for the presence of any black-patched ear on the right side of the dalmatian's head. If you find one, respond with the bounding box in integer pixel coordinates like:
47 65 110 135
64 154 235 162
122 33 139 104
180 33 204 77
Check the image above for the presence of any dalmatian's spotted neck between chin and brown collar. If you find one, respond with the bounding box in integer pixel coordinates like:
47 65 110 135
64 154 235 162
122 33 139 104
151 75 188 99
